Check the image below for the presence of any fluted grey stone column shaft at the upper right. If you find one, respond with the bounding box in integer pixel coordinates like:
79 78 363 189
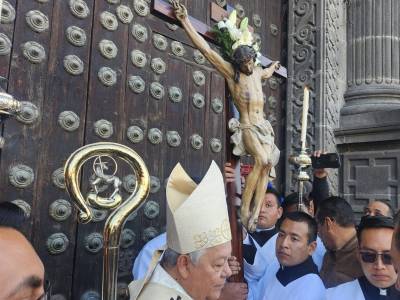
341 0 400 116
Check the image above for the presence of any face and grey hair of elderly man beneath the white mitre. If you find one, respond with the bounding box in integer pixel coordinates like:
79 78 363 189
185 242 232 300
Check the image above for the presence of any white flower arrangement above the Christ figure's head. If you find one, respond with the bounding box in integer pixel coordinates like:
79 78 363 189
213 10 261 65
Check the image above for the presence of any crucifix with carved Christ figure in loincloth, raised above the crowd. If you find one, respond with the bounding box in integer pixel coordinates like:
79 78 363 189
153 0 287 280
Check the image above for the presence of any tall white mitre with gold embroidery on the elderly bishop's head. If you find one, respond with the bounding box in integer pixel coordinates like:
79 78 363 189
166 161 232 254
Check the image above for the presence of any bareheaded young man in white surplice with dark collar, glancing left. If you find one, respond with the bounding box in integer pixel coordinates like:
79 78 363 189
254 212 326 300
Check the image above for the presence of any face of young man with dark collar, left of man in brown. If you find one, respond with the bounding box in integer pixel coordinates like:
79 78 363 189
275 219 317 267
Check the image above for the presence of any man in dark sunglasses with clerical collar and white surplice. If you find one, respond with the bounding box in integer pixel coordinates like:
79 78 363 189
327 216 400 300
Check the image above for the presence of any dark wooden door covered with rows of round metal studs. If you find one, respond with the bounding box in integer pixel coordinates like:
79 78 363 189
0 0 286 299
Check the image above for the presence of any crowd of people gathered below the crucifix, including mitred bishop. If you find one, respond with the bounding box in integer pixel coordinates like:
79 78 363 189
0 156 400 300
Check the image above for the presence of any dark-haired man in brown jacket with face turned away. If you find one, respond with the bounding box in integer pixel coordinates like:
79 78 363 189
316 196 363 288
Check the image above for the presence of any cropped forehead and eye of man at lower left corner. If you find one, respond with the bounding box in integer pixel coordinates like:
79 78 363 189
0 228 44 300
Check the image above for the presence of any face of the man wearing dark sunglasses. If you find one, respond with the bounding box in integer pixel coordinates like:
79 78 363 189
359 228 397 288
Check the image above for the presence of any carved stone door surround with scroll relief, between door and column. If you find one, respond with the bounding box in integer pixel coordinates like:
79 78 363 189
286 0 346 193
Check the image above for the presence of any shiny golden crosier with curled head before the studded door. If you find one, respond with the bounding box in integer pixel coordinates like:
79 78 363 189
64 142 150 300
